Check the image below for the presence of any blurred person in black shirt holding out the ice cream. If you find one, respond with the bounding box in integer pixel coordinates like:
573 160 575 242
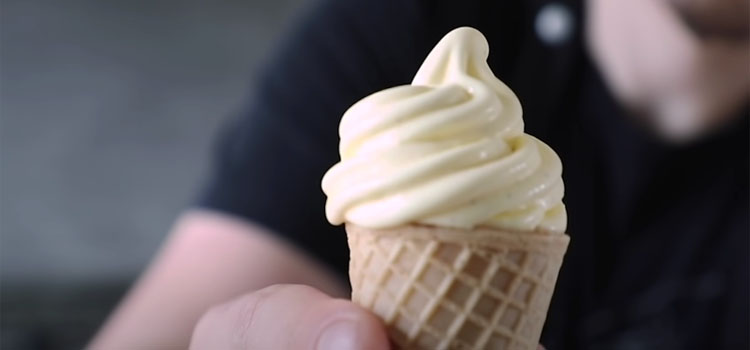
90 0 750 349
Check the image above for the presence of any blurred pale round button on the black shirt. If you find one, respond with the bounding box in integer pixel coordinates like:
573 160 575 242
534 3 573 46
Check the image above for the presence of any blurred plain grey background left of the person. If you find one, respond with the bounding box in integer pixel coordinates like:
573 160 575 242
0 0 301 349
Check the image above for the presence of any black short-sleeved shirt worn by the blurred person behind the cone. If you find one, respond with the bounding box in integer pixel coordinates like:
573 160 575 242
199 0 750 350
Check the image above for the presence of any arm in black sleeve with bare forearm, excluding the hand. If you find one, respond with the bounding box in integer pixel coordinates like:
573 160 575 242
91 0 426 349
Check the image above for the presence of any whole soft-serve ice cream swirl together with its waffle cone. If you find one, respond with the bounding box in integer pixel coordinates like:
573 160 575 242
321 27 569 350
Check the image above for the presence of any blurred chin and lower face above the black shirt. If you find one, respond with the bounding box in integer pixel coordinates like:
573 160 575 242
586 0 750 143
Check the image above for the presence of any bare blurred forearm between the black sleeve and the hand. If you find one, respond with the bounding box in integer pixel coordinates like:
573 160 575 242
89 211 347 349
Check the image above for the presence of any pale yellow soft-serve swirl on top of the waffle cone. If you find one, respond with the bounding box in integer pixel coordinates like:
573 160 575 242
322 27 567 233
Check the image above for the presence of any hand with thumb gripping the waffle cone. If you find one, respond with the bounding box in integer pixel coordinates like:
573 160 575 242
190 285 390 350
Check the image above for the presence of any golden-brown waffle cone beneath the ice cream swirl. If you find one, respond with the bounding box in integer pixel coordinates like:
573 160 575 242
346 224 569 350
